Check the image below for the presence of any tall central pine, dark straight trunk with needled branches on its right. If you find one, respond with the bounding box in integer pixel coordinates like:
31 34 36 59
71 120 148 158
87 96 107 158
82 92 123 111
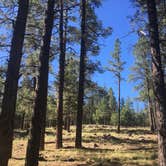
75 0 111 148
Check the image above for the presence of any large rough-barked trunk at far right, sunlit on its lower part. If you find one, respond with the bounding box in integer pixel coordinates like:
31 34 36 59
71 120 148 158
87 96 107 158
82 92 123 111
147 0 166 166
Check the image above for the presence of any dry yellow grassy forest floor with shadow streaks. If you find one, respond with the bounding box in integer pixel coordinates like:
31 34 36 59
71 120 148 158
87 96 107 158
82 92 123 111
9 125 157 166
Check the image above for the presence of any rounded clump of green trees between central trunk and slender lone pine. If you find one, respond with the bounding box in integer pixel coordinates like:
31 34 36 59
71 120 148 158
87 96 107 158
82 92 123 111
84 84 117 124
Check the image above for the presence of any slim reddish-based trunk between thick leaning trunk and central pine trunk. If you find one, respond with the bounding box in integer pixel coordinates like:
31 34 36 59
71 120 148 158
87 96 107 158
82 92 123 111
56 0 65 149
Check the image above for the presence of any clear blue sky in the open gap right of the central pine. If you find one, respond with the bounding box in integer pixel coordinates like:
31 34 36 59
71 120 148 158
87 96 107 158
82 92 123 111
93 0 143 108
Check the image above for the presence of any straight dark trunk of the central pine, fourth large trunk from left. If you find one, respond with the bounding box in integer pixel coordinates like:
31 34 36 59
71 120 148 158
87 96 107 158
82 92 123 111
75 0 86 148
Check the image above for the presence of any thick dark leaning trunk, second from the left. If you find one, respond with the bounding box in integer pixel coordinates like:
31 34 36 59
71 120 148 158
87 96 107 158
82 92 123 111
25 0 55 166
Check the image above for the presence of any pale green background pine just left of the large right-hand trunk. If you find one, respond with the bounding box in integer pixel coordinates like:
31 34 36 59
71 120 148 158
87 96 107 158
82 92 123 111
130 37 156 132
